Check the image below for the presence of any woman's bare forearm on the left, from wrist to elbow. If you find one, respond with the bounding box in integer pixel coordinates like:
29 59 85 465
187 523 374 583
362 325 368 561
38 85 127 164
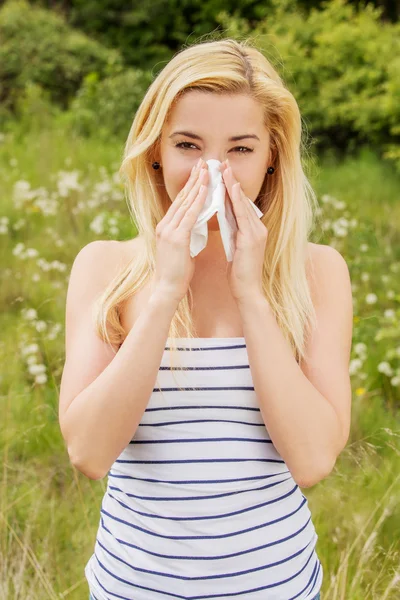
64 290 179 479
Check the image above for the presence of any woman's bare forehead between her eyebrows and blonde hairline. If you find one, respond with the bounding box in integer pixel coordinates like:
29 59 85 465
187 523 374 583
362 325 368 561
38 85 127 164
166 90 264 135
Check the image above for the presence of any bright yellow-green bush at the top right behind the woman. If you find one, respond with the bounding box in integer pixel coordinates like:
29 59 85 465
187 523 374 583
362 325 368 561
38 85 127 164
222 0 400 169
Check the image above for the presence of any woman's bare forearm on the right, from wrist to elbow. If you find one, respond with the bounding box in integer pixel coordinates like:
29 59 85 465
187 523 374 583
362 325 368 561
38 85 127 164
239 295 341 487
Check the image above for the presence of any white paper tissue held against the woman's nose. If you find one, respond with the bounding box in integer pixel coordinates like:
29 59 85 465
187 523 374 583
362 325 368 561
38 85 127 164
190 158 263 262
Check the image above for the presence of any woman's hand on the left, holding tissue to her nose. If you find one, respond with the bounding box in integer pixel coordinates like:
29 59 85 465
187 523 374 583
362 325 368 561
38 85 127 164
154 159 209 302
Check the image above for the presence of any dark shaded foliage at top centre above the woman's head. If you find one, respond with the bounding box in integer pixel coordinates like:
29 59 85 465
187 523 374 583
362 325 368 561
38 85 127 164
29 0 278 70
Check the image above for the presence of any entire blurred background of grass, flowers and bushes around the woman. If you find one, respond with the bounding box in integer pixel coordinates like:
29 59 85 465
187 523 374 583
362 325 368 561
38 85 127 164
0 0 400 600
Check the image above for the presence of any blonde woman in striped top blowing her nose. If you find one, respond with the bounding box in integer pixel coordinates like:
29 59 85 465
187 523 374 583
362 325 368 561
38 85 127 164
60 39 352 600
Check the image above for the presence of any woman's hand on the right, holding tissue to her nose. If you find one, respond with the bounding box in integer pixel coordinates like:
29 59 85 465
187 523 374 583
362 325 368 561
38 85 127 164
221 161 268 302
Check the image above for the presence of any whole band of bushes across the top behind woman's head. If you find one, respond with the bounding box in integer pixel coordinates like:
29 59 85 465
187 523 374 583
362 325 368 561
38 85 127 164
0 0 400 171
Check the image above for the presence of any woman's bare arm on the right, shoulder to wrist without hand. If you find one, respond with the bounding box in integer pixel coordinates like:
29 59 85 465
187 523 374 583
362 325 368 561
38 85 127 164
236 246 352 487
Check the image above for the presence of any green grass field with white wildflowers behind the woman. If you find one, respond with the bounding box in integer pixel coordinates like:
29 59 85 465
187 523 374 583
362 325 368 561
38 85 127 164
0 123 400 600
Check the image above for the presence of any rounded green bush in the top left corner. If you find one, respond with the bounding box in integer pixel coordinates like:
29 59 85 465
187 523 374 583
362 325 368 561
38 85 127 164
0 0 122 114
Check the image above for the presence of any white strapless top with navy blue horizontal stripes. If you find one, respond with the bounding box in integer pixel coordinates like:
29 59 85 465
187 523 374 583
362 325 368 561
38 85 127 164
85 337 323 600
